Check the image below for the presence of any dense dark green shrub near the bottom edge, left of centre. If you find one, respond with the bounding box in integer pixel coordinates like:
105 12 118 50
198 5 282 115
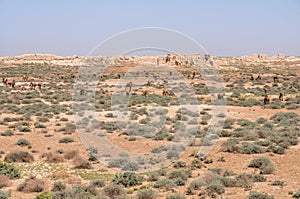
112 172 143 187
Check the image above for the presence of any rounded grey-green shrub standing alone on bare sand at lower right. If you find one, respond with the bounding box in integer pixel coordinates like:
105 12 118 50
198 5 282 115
248 157 275 174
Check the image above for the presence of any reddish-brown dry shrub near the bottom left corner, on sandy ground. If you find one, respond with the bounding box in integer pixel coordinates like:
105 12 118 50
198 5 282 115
17 178 46 192
